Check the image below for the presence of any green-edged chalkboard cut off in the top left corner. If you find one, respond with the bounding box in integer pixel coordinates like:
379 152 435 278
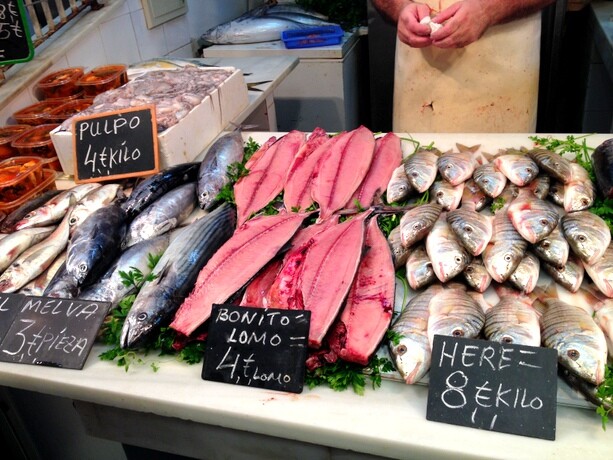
0 0 34 64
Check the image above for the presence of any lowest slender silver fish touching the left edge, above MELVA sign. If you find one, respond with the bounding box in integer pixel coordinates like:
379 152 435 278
0 204 74 292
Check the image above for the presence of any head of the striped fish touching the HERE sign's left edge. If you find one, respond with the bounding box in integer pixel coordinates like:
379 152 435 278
388 333 432 384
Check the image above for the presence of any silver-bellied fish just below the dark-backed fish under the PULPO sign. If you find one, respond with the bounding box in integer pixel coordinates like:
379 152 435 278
125 182 196 247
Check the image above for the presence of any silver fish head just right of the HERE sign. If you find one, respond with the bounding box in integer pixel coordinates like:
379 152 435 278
557 331 607 385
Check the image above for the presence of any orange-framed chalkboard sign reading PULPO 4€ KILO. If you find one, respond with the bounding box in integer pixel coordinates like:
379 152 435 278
73 105 159 182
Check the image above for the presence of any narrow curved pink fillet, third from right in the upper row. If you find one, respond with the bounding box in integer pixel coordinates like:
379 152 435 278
283 128 337 211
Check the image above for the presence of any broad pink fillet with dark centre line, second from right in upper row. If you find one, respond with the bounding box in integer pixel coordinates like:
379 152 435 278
313 126 375 219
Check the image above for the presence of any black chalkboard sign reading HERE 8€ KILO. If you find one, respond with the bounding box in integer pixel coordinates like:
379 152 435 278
426 335 557 440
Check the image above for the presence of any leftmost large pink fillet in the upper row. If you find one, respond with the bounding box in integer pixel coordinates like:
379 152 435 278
234 130 305 226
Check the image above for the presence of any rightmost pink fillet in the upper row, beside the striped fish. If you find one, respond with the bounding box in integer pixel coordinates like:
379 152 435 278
345 133 402 209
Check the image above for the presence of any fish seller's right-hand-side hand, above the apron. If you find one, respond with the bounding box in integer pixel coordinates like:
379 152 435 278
430 0 491 48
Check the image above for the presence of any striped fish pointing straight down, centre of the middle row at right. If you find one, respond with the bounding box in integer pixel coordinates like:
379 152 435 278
481 202 528 283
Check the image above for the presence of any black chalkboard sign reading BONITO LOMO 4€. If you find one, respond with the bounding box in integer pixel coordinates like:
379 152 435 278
202 305 311 393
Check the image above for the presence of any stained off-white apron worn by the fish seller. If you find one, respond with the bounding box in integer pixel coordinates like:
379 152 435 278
393 0 541 133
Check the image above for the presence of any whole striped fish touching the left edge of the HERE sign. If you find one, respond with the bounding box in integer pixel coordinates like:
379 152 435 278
388 284 443 384
